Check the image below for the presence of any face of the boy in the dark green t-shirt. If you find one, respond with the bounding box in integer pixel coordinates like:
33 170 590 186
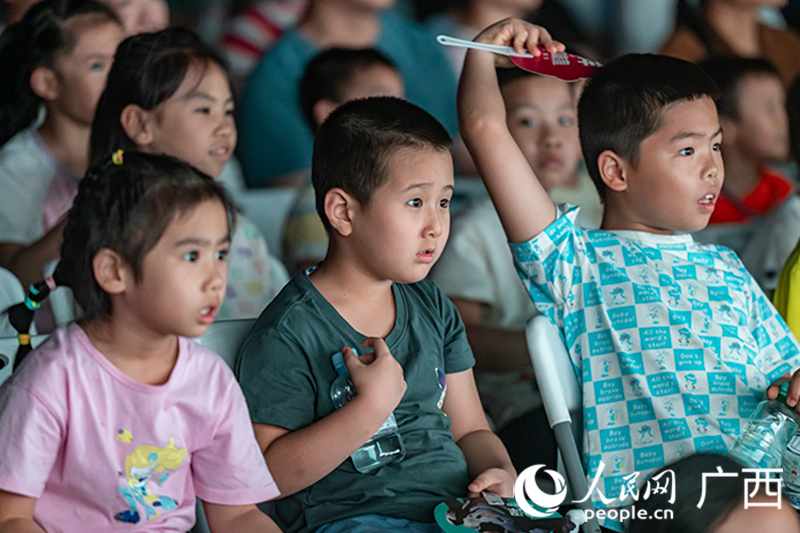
351 148 454 283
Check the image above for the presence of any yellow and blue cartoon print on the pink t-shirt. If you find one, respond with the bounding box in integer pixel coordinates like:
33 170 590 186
114 436 187 524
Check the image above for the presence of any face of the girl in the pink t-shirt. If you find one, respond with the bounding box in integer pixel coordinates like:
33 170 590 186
122 199 230 337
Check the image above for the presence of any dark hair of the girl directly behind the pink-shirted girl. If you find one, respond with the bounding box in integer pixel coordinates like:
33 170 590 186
90 28 230 161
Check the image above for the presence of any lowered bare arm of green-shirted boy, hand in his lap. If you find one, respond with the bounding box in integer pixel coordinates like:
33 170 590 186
442 369 517 498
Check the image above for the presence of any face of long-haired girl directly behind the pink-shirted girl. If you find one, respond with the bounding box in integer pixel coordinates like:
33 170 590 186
140 62 236 178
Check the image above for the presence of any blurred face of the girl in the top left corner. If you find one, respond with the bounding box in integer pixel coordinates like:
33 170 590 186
45 14 125 127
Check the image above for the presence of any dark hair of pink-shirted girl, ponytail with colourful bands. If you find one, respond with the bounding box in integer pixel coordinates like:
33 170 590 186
8 151 236 368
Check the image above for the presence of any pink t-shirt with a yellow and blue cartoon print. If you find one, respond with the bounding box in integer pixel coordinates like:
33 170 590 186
0 324 279 533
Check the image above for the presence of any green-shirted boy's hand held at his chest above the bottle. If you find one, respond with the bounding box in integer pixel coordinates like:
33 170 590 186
342 337 407 416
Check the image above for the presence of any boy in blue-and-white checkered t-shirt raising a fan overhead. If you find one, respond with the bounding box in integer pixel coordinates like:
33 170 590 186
459 20 800 530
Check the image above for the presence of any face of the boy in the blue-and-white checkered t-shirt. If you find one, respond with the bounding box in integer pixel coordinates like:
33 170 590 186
620 97 725 234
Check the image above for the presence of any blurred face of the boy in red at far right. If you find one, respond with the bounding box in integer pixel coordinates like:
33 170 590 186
734 74 789 162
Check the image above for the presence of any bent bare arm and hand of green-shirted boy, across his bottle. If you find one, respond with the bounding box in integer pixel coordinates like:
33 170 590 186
253 338 406 496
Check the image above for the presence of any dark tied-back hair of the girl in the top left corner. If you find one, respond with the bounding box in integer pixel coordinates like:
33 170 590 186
0 0 119 146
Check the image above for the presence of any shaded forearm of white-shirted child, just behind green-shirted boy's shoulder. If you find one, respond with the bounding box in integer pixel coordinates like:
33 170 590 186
451 298 532 372
